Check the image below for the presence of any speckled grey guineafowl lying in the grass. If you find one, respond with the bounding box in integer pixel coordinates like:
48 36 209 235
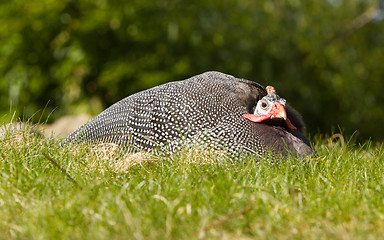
61 71 313 159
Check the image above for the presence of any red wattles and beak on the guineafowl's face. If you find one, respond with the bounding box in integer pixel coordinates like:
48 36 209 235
243 103 297 130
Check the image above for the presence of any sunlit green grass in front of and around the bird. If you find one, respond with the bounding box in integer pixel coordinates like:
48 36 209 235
0 124 384 239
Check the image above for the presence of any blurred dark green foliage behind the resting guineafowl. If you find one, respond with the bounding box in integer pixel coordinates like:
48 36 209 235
0 0 384 140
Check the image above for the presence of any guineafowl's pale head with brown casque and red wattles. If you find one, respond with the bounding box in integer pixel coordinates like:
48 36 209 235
243 86 296 130
